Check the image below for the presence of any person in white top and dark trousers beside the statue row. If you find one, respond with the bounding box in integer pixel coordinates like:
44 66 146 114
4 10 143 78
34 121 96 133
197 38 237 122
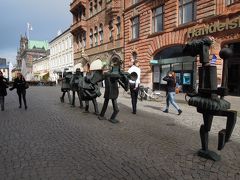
128 60 141 114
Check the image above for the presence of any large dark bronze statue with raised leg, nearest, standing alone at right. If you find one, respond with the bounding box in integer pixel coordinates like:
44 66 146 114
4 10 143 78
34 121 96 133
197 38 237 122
184 37 237 161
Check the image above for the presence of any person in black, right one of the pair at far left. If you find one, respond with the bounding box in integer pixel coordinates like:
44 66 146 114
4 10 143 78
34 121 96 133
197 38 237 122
9 72 27 109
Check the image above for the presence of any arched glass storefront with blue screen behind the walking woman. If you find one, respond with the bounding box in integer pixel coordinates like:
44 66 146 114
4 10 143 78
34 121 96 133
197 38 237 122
150 45 196 92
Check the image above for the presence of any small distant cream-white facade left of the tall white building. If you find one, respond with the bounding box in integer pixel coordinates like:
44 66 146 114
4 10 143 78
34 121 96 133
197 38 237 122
33 56 50 81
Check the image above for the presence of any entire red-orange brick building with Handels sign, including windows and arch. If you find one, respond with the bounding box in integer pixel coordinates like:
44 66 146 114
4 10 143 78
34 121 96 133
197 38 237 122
124 0 240 95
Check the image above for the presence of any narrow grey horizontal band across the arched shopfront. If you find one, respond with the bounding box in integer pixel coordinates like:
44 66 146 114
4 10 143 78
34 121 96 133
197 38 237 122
150 56 195 65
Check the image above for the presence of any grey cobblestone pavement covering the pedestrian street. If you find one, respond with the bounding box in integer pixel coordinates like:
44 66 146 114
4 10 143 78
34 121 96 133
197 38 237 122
0 87 240 180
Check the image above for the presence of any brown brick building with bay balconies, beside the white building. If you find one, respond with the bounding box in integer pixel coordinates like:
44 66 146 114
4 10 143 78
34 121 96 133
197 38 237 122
70 0 124 69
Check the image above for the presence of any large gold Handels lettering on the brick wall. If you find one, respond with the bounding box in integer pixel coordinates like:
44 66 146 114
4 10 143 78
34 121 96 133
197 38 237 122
187 16 240 38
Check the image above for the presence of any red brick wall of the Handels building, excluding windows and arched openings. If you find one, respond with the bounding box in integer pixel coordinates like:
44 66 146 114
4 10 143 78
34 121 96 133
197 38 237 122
124 0 240 93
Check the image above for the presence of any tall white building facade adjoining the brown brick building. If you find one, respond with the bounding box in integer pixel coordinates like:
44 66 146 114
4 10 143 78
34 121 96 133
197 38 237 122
49 28 74 82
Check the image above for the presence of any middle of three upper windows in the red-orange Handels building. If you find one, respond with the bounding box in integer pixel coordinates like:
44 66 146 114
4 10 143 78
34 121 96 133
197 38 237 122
152 6 163 33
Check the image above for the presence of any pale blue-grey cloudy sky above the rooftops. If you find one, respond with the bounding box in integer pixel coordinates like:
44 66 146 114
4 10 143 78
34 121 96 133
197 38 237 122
0 0 72 64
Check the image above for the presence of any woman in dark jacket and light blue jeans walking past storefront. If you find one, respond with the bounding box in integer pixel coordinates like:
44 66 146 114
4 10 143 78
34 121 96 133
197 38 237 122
163 71 182 115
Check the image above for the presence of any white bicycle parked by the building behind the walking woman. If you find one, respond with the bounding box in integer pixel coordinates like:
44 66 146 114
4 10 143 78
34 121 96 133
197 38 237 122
138 86 165 102
